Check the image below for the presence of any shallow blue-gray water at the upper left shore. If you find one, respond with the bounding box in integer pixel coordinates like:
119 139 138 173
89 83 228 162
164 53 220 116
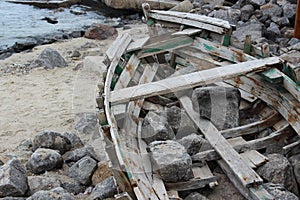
0 0 105 50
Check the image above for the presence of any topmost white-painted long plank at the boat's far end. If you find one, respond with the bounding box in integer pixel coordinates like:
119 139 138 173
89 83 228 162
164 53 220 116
150 10 231 30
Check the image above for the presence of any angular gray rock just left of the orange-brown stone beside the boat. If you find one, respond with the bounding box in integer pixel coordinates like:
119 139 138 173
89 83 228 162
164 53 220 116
67 156 97 185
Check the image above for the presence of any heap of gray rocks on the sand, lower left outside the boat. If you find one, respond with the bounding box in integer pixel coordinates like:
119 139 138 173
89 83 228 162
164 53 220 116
0 131 118 200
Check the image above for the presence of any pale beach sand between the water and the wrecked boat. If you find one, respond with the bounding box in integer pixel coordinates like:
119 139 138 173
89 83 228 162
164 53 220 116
0 25 145 153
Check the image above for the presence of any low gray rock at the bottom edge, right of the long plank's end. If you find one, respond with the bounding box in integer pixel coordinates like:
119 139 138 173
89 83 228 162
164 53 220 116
263 183 299 200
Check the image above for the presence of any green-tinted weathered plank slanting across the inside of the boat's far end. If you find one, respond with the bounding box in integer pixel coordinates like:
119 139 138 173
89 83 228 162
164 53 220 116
138 36 194 58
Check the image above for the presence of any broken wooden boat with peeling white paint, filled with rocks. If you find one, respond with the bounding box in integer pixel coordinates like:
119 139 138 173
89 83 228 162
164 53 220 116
97 5 300 200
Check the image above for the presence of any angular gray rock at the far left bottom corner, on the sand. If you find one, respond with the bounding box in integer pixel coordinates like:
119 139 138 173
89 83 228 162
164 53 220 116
0 159 28 197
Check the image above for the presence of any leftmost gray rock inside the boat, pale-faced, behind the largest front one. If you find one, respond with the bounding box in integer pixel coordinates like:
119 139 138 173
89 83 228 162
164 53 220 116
142 111 175 143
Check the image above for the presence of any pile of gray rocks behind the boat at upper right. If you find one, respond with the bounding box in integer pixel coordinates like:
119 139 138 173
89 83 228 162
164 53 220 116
191 0 300 55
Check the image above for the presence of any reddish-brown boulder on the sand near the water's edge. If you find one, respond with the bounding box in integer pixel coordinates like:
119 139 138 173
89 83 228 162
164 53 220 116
84 23 118 40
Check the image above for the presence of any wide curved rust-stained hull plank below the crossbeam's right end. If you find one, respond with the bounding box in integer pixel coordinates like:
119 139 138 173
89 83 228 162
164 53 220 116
226 75 300 135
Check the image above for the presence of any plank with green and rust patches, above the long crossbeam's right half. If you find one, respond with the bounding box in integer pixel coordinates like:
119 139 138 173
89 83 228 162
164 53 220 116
194 37 255 63
